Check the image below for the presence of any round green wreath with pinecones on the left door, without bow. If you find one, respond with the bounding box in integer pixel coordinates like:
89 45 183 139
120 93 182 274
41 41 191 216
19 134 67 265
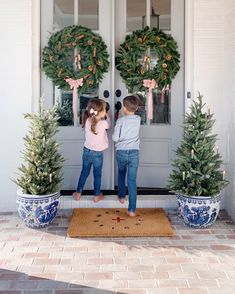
42 25 109 92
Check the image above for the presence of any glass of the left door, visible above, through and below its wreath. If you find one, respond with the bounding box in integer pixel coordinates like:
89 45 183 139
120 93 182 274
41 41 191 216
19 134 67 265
53 0 99 126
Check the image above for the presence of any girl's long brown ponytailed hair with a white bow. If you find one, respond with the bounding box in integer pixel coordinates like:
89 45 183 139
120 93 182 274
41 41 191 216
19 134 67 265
82 98 106 135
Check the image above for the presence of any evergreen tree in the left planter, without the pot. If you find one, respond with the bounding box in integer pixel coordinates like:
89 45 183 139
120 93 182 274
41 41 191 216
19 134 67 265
14 101 64 195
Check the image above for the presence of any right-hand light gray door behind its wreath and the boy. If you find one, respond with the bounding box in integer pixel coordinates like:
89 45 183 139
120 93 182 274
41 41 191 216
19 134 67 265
115 0 184 188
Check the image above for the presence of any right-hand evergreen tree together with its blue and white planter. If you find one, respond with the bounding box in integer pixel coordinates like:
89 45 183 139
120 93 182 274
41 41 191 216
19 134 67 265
169 94 228 228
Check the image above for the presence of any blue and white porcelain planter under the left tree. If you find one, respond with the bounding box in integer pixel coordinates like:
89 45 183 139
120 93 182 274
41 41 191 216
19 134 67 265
16 190 60 228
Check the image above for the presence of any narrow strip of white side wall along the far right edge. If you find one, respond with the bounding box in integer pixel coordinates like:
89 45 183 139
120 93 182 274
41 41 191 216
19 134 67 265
223 0 235 220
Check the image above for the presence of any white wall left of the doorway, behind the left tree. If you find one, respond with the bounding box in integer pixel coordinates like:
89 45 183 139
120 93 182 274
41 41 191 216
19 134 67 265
0 0 32 211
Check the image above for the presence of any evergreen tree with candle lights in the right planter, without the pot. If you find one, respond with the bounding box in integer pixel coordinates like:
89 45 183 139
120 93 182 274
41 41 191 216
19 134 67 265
169 94 227 197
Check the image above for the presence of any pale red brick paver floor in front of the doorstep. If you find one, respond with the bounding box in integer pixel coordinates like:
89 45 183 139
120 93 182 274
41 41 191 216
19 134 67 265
0 210 235 294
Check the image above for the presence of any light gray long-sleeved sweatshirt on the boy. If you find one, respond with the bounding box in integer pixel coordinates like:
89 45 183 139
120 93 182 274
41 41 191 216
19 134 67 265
113 114 140 150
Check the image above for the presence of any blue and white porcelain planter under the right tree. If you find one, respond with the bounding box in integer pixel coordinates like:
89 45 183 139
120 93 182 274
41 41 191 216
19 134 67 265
176 194 221 228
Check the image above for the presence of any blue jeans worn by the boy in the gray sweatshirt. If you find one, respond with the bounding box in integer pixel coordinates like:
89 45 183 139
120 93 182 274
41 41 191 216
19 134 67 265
116 149 139 212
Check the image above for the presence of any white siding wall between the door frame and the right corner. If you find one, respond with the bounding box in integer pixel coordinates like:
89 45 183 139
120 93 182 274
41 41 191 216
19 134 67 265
193 0 231 208
